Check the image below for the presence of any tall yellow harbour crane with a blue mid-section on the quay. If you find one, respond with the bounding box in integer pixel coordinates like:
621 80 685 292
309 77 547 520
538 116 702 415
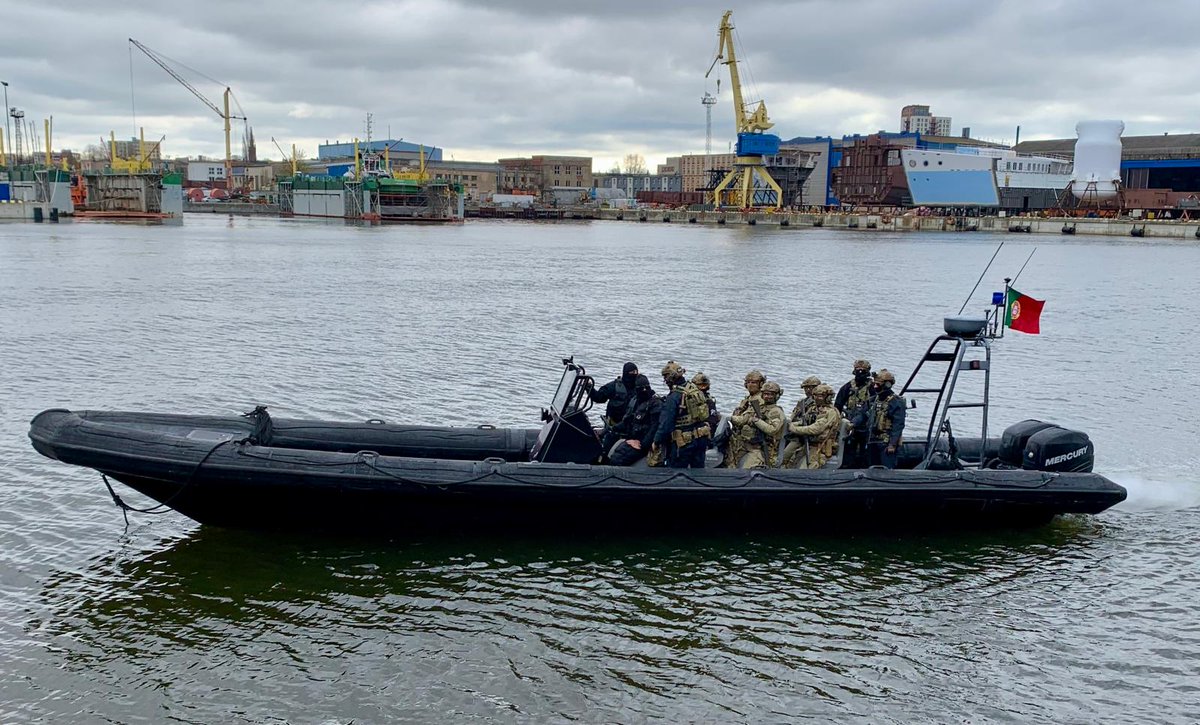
704 10 784 209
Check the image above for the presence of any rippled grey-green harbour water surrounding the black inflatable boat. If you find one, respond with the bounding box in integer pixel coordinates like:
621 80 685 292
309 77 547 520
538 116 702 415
0 215 1200 723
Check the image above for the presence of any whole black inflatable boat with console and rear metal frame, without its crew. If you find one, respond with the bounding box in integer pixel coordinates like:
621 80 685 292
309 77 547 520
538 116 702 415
29 318 1126 532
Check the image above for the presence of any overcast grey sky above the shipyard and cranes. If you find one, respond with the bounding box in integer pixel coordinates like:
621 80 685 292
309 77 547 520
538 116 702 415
0 0 1200 170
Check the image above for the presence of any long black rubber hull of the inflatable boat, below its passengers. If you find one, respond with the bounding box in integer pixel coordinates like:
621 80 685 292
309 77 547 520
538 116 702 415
29 409 1126 533
